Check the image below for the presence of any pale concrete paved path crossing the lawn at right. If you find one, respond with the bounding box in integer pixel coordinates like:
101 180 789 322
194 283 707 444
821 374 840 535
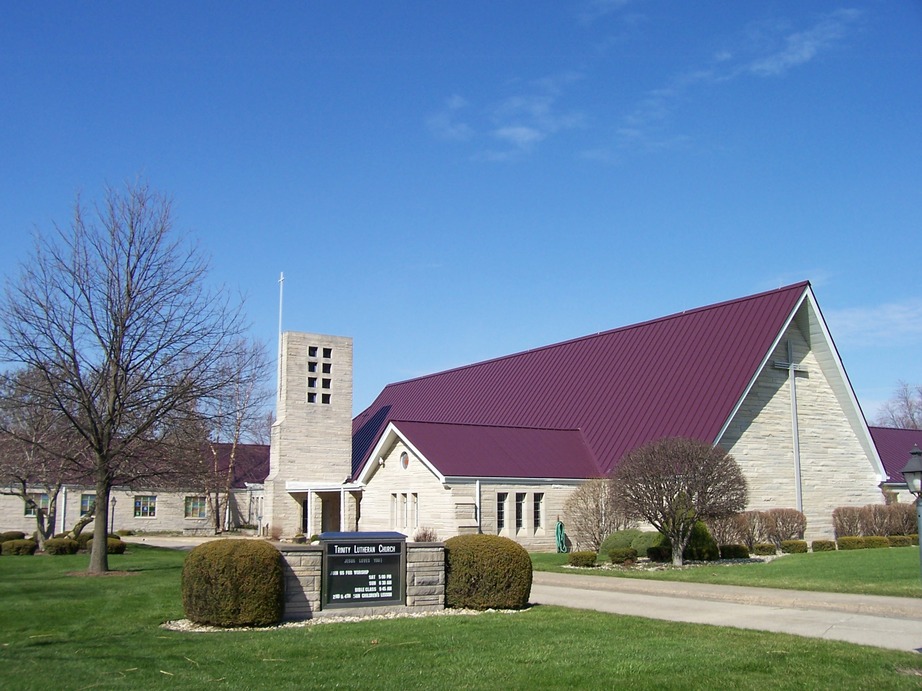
531 571 922 652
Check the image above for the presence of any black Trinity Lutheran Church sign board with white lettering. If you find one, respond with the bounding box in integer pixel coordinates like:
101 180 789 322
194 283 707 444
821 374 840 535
320 532 407 609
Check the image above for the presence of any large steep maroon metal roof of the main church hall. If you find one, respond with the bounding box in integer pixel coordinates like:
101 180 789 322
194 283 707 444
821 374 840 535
352 282 809 477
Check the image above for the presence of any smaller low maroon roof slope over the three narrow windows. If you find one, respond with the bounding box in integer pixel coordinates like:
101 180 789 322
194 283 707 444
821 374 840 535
394 420 599 479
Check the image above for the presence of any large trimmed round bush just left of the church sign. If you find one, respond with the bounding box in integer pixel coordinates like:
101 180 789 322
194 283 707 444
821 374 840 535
182 540 285 627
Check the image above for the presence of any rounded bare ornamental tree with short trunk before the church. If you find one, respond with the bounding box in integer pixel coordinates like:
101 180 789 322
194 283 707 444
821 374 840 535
612 438 747 566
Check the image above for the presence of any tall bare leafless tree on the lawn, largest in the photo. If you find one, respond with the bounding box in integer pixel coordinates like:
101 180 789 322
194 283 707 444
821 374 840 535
0 183 244 573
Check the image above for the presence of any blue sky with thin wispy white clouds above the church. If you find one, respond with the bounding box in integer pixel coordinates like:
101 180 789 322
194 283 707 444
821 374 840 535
0 0 922 419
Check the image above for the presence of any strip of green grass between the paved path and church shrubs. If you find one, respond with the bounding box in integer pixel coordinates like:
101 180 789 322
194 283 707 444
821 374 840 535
531 547 922 597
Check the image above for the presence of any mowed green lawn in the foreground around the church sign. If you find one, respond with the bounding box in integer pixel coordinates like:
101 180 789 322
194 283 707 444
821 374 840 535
0 545 922 690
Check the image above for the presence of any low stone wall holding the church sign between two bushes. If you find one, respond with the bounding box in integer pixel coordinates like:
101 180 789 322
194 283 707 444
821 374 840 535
279 542 445 621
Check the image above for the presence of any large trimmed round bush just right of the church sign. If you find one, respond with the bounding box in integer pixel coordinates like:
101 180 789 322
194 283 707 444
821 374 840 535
445 534 532 610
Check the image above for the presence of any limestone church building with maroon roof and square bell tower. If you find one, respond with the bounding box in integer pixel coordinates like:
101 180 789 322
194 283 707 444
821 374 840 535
265 282 892 550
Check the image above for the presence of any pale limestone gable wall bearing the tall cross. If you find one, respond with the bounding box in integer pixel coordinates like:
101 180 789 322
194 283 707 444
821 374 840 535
720 324 883 540
